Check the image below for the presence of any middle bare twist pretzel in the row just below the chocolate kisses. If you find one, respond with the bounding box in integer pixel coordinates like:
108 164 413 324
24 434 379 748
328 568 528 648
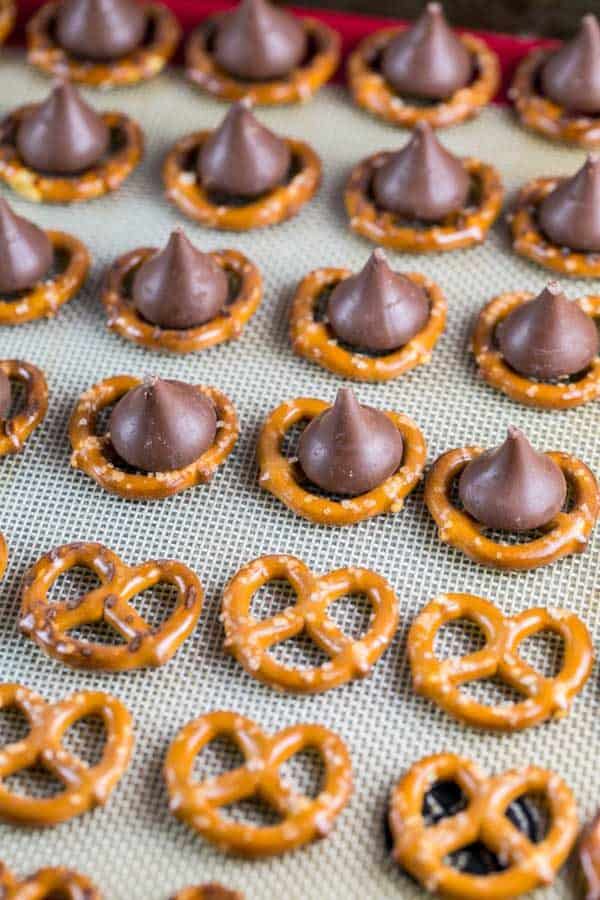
222 555 398 693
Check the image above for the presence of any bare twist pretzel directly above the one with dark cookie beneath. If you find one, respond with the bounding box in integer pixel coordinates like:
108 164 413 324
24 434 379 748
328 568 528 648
408 594 594 731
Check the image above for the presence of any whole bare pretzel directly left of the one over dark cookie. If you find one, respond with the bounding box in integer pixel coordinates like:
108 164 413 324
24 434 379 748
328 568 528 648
164 711 352 858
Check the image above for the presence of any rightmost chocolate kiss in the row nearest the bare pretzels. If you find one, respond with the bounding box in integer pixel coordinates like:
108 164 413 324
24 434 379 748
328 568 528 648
458 426 567 531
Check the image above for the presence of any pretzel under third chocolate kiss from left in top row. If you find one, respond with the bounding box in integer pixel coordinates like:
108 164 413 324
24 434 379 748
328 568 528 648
348 27 500 128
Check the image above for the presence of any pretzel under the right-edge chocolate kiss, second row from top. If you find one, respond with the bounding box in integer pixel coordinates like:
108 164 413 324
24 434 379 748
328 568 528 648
509 178 600 278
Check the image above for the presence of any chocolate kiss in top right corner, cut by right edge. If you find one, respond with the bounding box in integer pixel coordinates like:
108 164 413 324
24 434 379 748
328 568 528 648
541 13 600 115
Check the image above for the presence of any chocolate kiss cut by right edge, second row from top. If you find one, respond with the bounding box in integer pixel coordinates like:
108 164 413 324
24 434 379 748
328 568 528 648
538 153 600 253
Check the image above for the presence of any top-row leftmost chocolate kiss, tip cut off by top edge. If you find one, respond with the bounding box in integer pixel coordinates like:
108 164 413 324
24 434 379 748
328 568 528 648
56 0 146 62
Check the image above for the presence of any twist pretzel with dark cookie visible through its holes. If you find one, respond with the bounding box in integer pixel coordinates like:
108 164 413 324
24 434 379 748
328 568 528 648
390 753 577 900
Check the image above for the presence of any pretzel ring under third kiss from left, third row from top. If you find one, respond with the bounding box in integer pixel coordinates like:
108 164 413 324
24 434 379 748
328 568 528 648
290 269 447 381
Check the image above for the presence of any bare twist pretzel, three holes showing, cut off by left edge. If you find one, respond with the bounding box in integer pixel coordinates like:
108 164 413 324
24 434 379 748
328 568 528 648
0 684 133 827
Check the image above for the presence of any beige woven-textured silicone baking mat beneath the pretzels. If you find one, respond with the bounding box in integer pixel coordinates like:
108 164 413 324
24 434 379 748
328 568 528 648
0 52 600 900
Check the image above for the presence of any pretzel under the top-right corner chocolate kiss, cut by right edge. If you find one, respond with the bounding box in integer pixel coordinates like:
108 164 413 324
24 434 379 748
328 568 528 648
508 47 600 150
